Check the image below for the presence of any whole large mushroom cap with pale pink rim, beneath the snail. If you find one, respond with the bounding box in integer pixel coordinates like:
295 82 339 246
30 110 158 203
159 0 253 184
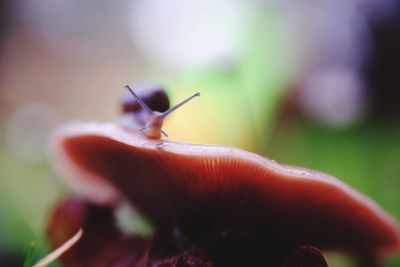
51 122 400 261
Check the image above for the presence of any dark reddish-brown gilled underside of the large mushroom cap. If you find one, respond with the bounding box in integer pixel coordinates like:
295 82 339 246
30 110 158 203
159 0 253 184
50 126 400 266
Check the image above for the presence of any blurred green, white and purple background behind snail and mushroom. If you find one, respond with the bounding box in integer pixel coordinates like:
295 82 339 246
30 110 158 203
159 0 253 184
0 0 400 267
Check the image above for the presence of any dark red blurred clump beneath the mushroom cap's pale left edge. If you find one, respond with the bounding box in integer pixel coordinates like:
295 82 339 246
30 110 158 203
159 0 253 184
47 198 151 267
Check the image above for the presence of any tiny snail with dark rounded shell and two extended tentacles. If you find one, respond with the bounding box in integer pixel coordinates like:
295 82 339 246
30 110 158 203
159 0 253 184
122 82 200 139
